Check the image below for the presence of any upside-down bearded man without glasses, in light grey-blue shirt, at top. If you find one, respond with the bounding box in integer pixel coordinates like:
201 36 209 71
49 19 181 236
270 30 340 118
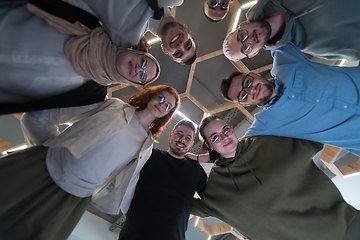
64 0 197 65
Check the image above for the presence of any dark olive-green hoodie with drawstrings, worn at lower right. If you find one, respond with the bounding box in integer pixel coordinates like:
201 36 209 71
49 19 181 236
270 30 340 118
192 136 360 240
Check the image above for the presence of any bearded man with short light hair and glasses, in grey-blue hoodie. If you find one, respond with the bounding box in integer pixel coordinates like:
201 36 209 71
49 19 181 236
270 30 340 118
223 0 360 61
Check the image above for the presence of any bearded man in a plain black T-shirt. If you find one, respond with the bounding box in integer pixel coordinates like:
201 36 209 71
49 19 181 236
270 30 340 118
119 120 207 240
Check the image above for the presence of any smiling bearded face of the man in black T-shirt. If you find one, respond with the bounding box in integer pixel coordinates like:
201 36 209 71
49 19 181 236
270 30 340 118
168 125 195 158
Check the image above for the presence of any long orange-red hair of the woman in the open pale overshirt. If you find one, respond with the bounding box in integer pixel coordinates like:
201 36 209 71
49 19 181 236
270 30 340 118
128 85 180 139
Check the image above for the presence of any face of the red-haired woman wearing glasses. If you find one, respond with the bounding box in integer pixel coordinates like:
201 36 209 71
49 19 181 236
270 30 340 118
146 91 176 118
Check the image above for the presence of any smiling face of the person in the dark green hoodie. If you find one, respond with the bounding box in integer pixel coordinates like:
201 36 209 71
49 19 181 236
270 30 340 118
204 119 237 158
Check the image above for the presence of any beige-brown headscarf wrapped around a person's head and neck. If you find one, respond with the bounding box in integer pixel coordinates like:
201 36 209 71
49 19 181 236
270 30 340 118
27 3 160 86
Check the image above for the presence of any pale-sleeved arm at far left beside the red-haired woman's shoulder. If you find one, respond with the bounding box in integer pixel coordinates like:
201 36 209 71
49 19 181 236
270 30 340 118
21 103 101 145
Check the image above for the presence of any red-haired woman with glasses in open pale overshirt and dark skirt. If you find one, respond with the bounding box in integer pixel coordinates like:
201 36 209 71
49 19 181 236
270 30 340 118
0 85 180 240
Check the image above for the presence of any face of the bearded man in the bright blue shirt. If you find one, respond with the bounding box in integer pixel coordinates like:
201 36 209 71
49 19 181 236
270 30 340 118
228 73 276 106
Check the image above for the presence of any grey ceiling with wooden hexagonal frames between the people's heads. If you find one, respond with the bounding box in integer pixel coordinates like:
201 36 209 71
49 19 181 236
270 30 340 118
109 0 272 152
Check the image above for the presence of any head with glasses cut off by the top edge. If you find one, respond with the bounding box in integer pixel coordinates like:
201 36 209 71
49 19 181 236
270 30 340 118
204 0 233 22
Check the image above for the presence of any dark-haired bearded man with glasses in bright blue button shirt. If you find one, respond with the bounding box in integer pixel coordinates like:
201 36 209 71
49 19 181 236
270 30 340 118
221 43 360 156
